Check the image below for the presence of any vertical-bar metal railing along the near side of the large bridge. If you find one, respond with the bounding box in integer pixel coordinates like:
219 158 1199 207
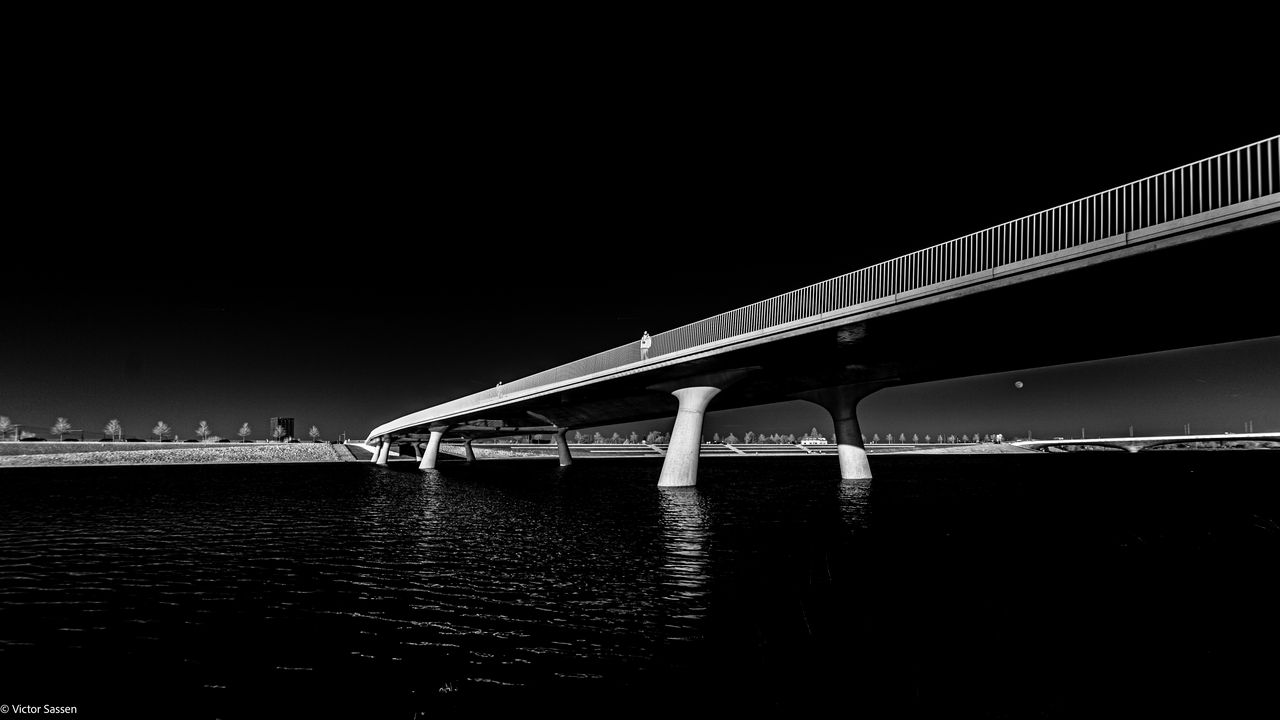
381 136 1280 427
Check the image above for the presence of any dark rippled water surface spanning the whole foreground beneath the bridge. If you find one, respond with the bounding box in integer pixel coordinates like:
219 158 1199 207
0 451 1280 719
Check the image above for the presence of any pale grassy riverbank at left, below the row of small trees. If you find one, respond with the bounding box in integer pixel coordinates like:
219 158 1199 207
0 442 353 468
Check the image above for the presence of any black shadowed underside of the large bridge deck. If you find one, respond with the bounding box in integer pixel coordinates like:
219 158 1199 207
373 210 1280 484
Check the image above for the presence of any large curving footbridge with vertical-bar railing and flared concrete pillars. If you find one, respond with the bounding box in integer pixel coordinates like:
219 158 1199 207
366 136 1280 487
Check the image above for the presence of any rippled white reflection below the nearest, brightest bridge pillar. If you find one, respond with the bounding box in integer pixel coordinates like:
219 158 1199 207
658 487 710 637
